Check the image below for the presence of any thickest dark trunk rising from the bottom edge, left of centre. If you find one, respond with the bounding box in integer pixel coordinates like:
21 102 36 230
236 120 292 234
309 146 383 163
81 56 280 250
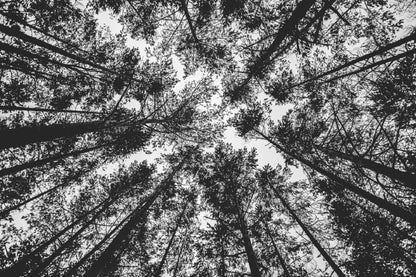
84 158 186 277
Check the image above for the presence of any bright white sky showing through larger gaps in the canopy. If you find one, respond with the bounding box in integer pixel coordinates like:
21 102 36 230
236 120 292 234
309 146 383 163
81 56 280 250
96 11 306 181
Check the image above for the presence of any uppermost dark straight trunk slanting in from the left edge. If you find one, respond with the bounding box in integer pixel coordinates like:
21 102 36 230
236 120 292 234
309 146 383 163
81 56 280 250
0 24 115 74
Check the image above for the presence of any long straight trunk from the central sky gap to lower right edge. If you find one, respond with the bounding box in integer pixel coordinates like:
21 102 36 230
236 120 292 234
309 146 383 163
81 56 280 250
255 130 416 226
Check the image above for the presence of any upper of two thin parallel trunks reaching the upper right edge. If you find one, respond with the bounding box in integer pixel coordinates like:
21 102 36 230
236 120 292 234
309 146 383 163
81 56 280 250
289 33 416 89
